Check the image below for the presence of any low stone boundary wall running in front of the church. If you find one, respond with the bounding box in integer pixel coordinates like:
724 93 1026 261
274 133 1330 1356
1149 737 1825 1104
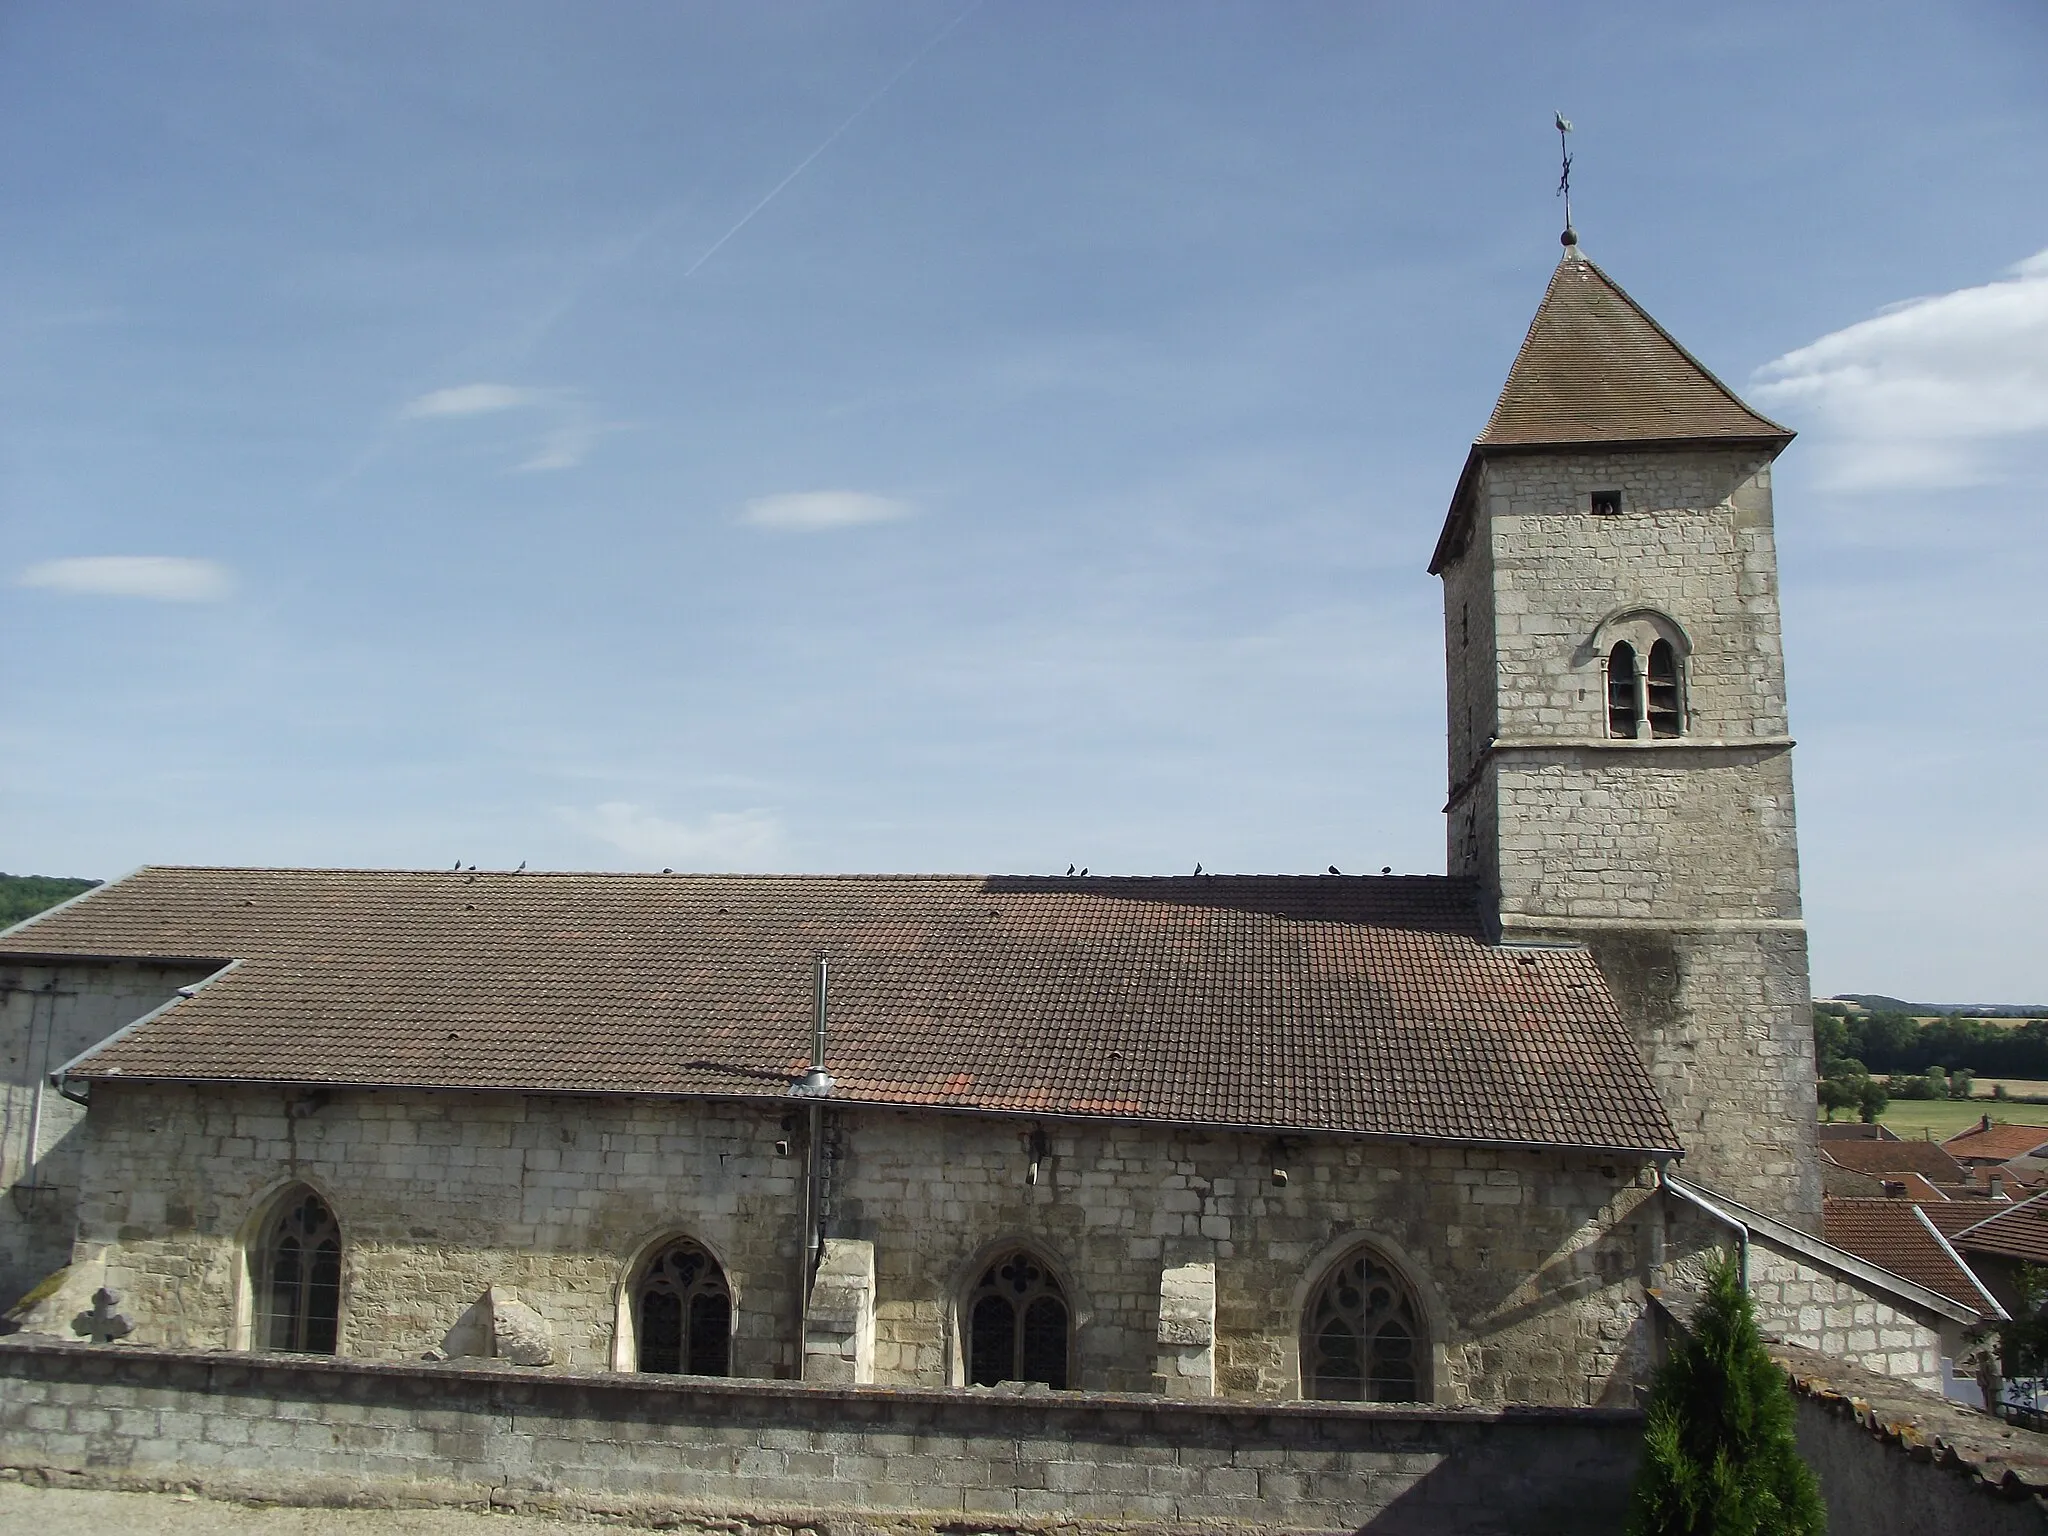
0 1339 1642 1536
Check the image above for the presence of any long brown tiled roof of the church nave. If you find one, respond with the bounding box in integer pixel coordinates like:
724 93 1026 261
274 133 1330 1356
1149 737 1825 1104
0 868 1677 1151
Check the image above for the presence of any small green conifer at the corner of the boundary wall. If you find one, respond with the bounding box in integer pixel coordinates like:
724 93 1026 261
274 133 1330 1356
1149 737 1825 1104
1628 1253 1827 1536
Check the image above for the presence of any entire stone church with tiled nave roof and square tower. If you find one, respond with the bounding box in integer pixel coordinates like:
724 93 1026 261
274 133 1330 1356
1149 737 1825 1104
0 231 1964 1407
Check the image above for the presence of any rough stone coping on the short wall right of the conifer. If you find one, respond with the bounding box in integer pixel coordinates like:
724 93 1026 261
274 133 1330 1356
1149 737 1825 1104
1772 1343 2048 1499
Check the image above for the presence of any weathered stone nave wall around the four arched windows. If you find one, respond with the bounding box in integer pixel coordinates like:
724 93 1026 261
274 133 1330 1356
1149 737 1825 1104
74 1081 1651 1403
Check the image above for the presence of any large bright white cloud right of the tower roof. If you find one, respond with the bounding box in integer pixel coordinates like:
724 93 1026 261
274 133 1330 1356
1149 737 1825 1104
1753 250 2048 489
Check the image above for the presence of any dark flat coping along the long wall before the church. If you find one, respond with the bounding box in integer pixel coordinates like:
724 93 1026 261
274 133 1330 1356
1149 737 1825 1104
0 1333 1638 1438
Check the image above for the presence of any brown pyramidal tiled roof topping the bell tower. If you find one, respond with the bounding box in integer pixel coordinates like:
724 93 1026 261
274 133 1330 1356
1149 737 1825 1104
1475 244 1792 451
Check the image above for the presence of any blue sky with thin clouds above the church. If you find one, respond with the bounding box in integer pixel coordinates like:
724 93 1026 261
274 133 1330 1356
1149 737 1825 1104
0 0 2048 1001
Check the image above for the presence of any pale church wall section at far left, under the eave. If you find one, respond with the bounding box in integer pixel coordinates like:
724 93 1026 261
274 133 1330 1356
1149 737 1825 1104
0 961 217 1311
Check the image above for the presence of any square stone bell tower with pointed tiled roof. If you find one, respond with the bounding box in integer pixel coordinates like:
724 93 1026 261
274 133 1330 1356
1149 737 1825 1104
1430 231 1821 1227
